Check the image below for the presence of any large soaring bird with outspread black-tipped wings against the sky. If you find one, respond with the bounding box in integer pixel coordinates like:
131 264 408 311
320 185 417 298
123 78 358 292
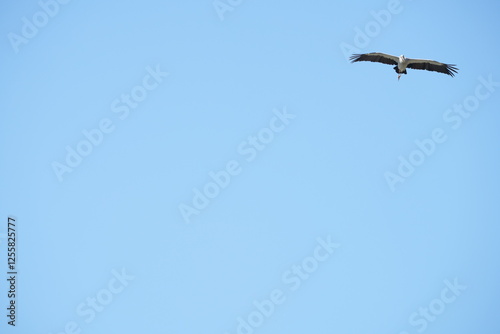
350 52 458 80
